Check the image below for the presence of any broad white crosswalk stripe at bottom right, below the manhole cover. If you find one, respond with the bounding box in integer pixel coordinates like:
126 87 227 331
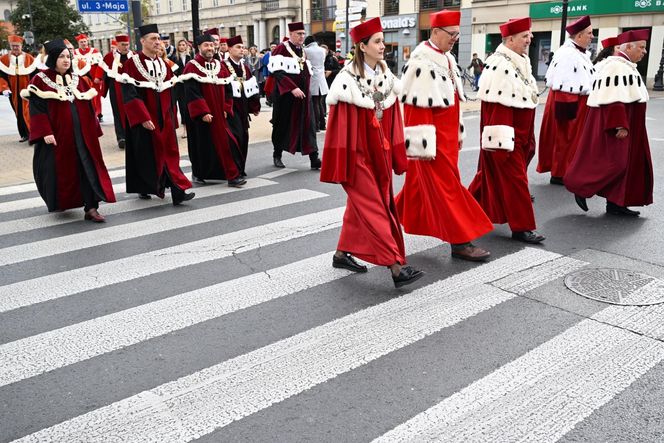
374 320 664 443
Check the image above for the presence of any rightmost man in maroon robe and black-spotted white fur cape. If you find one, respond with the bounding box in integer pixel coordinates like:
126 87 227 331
565 29 654 217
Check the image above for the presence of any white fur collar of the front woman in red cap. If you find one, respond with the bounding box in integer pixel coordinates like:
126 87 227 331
326 62 401 109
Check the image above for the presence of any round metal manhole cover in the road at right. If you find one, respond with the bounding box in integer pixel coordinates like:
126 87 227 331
565 268 664 306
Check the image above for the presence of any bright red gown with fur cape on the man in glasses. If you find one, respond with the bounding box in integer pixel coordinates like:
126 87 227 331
395 43 493 244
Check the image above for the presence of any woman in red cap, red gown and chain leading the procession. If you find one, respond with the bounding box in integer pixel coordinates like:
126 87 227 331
320 18 423 288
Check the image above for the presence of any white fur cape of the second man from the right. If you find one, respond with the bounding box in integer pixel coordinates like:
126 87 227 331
546 40 595 95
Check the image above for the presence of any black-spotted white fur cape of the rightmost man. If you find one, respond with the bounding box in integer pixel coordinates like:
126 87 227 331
588 56 650 108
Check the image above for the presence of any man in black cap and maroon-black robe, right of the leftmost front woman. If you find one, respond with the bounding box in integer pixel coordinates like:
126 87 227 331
120 24 195 206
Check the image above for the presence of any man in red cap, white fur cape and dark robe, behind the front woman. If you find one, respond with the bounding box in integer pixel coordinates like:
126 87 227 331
268 22 320 169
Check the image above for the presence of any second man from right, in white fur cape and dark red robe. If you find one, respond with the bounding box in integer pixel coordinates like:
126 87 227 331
537 15 595 185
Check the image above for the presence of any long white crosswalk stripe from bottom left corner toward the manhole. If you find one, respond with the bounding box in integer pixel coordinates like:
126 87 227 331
11 248 559 442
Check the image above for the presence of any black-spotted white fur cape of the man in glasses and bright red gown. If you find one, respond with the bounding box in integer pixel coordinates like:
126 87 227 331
401 42 466 108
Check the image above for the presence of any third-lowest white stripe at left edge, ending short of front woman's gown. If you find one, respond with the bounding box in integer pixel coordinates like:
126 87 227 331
0 189 328 266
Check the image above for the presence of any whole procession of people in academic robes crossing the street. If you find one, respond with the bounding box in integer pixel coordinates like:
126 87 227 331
0 10 653 287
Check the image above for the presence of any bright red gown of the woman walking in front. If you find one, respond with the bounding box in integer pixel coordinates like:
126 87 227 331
320 67 407 266
